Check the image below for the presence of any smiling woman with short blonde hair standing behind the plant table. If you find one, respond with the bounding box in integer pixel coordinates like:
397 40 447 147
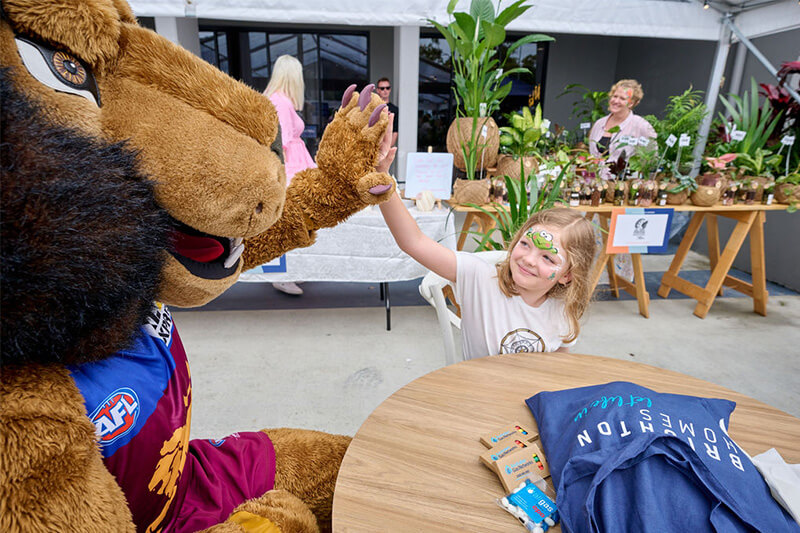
589 80 656 179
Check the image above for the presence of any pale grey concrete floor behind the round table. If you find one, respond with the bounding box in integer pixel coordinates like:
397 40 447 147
173 247 800 438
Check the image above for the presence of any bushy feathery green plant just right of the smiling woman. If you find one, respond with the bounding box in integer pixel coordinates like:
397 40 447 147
644 87 708 168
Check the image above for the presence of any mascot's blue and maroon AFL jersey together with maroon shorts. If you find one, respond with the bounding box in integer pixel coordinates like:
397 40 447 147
69 304 275 531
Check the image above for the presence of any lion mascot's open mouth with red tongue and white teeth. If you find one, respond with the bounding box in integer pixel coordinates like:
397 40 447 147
169 219 244 279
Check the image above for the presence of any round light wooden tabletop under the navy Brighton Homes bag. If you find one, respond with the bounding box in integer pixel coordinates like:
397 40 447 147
333 353 800 533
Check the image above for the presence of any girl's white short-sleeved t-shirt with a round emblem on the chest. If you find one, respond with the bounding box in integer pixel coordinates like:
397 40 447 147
455 252 575 359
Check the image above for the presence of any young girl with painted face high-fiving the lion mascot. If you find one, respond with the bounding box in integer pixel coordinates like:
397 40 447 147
380 187 595 359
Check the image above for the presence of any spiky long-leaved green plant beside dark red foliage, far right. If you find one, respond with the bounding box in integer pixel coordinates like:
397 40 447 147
711 78 781 157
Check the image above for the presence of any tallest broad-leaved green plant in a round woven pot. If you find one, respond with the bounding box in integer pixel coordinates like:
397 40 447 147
428 0 553 203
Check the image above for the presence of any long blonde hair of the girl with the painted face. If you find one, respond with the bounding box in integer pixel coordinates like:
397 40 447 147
497 207 597 342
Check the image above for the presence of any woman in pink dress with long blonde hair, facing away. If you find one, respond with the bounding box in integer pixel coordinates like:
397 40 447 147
264 55 317 296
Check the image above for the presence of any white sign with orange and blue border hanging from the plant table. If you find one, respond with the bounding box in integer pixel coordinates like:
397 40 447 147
606 207 674 254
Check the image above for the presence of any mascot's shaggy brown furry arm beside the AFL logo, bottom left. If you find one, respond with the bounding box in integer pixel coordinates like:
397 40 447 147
0 365 134 532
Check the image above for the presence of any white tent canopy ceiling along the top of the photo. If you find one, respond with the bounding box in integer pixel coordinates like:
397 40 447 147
130 0 800 41
